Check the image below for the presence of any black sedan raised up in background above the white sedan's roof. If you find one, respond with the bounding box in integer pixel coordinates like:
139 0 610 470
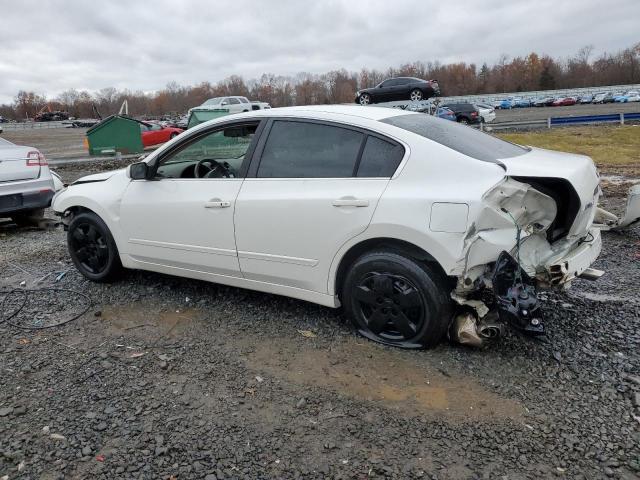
356 77 440 105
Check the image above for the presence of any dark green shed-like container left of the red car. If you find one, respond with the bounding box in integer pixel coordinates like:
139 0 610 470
86 115 144 155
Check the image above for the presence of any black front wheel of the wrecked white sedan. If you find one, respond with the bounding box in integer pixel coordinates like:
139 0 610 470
67 212 123 283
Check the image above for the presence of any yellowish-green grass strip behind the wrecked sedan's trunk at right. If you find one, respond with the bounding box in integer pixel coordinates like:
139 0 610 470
496 125 640 167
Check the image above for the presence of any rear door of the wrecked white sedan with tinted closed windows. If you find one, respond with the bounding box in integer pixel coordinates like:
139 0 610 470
235 119 404 293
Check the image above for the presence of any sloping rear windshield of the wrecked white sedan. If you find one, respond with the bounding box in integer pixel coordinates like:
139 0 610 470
381 113 529 162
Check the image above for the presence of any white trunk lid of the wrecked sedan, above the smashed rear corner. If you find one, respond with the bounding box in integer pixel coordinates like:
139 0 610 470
499 147 600 205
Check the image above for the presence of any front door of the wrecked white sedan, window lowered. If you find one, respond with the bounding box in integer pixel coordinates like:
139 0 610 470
122 122 257 276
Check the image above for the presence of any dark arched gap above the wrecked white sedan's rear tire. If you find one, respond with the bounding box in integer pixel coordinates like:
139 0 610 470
335 238 449 295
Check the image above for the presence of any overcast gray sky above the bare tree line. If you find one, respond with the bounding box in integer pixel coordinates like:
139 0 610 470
0 0 640 103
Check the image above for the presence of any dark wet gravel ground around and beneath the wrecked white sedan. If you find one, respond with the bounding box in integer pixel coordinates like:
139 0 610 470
0 162 640 480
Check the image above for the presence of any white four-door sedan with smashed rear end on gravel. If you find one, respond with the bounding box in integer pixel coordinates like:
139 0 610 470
53 106 632 348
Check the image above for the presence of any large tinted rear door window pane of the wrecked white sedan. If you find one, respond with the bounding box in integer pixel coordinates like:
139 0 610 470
257 120 365 178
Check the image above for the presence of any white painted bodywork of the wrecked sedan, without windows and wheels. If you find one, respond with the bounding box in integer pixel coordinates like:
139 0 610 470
53 106 620 307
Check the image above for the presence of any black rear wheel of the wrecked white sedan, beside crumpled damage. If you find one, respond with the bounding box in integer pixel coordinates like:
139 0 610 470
341 250 451 349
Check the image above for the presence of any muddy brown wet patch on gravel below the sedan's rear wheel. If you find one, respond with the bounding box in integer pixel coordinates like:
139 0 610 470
248 339 524 419
